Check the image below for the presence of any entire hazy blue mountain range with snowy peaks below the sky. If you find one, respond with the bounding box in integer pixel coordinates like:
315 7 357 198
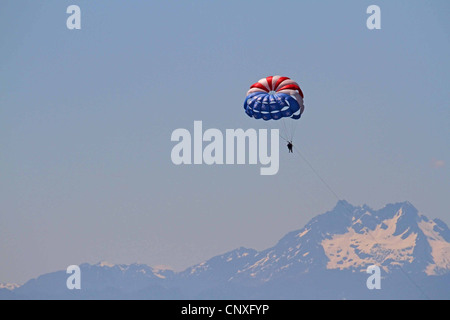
4 201 450 299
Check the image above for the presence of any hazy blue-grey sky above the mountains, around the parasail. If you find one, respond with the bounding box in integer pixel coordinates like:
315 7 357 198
0 0 450 283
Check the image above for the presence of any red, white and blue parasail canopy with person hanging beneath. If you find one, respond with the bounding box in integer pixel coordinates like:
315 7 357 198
244 76 305 153
